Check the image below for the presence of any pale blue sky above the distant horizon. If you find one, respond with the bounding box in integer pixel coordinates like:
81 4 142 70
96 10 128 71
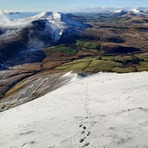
0 0 148 11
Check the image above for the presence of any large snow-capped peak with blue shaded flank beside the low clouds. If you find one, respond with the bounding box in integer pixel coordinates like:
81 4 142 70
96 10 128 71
20 12 88 41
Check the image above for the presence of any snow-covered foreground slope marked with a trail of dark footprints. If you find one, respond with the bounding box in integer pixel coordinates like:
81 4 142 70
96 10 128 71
0 72 148 148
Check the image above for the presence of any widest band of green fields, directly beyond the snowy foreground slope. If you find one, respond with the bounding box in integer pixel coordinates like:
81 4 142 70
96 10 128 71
56 55 148 73
